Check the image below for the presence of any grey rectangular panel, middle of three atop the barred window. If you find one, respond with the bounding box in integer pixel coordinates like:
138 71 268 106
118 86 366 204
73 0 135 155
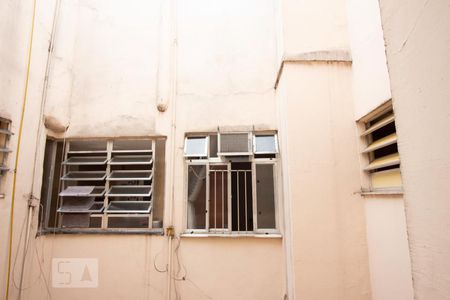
217 132 253 156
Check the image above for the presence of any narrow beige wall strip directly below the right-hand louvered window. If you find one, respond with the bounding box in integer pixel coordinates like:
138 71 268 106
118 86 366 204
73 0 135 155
365 196 414 300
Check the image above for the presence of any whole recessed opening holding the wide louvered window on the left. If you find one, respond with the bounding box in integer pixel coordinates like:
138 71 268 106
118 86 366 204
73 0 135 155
40 138 165 233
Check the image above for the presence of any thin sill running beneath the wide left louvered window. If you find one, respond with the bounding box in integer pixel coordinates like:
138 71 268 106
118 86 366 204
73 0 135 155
37 228 164 236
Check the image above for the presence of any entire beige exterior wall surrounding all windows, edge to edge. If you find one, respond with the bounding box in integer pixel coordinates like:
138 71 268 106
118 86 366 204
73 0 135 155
0 0 450 300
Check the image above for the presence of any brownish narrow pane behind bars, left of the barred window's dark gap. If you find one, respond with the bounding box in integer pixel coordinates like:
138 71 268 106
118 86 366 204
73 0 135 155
209 165 228 229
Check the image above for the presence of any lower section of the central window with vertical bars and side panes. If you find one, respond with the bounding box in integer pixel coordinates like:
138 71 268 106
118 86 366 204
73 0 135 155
187 161 276 233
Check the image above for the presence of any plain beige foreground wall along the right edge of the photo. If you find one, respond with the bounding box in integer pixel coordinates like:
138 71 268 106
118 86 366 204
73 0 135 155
380 0 450 299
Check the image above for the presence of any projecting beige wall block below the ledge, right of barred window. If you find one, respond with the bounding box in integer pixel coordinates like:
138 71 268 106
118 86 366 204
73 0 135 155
277 62 371 299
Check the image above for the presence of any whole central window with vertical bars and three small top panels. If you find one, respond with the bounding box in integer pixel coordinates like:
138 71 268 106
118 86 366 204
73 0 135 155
185 132 279 235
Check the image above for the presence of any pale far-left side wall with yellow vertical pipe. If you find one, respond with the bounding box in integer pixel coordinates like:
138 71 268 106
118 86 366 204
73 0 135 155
0 1 54 298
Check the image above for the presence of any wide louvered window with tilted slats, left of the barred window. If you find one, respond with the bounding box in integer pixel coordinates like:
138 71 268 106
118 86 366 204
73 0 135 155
43 139 160 230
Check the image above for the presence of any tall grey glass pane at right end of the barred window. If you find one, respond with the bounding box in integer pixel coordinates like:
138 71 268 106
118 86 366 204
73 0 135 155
256 164 276 228
